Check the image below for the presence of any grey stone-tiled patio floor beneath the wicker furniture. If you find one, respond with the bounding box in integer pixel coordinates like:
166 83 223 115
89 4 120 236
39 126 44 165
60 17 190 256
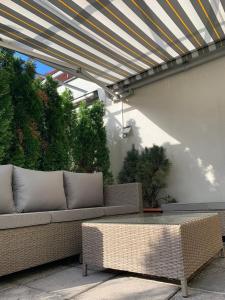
0 257 225 300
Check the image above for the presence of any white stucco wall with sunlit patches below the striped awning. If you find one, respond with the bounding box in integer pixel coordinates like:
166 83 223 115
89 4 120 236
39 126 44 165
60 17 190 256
106 58 225 202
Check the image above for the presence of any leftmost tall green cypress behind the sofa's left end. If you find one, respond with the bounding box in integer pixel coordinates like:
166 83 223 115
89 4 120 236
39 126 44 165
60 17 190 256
0 49 42 169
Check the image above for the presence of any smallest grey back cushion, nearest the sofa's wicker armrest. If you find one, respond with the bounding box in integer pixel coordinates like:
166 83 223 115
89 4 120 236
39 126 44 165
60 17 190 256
64 172 103 208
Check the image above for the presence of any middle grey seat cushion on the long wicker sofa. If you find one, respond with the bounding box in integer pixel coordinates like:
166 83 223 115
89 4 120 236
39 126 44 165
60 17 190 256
49 207 104 223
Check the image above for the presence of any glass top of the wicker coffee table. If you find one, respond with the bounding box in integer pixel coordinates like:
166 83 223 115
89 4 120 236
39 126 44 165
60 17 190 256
84 213 217 225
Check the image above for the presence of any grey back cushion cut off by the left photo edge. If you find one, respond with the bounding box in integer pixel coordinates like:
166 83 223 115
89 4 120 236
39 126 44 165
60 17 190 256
0 165 15 214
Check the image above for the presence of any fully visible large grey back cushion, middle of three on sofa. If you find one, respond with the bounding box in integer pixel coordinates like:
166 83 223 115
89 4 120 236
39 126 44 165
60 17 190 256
13 167 67 212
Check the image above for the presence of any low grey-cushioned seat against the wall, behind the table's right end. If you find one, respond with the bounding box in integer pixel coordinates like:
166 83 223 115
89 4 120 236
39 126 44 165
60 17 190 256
161 202 225 237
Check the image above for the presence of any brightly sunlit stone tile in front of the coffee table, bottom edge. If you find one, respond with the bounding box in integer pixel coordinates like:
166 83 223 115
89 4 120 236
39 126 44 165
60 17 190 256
74 276 179 300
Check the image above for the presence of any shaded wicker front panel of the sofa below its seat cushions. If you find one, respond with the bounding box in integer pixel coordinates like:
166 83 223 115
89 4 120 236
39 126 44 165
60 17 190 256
0 221 81 276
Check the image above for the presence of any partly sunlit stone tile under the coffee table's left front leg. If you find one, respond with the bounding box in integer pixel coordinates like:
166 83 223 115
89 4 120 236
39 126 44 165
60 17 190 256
27 267 116 298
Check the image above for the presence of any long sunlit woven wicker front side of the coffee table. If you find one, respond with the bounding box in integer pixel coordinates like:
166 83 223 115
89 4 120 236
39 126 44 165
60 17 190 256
83 224 182 278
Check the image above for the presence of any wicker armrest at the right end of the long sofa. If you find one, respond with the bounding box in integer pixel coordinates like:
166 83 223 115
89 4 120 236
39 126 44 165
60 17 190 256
104 183 143 212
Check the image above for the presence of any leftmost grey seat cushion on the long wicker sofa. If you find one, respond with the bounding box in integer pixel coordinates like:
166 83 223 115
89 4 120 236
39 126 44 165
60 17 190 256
0 212 51 229
